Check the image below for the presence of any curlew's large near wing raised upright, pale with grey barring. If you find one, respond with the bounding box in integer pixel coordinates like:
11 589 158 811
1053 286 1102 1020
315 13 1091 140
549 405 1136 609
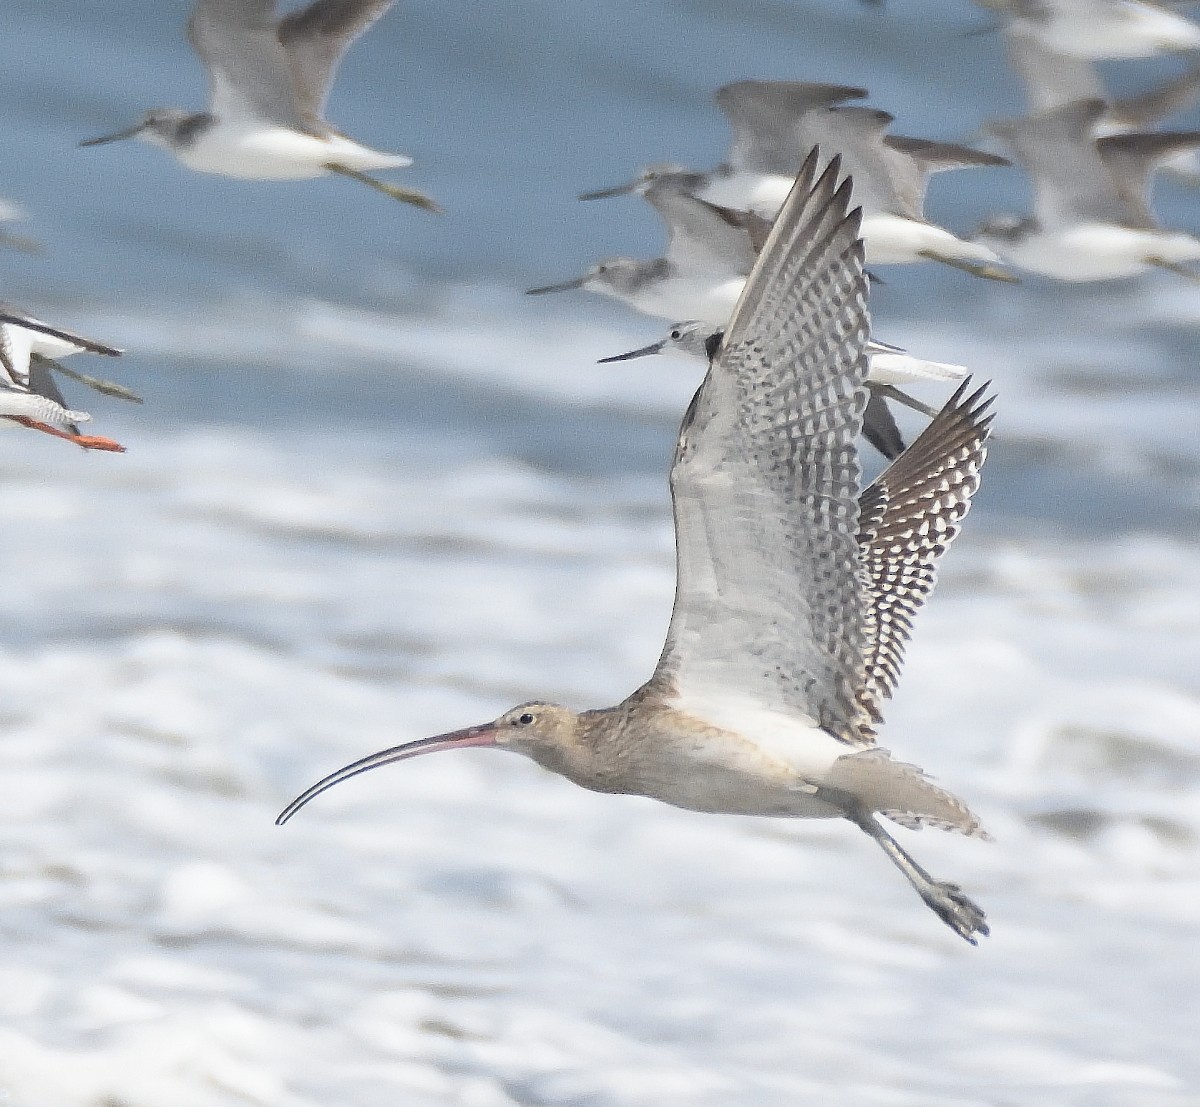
655 150 871 744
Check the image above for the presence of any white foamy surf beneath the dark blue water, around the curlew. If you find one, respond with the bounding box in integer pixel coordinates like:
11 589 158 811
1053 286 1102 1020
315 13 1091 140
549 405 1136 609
0 386 1200 1107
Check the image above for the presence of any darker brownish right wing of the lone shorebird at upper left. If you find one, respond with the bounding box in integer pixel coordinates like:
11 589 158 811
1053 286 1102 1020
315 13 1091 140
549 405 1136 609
278 0 395 120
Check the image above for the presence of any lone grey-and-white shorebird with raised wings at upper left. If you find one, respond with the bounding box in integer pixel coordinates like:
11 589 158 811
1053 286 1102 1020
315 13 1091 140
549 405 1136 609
79 0 440 211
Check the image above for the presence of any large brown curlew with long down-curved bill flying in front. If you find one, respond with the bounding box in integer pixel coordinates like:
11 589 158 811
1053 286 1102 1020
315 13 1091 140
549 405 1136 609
277 151 990 944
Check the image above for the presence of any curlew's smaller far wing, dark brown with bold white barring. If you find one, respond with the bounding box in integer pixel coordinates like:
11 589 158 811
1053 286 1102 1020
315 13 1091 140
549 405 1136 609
859 377 995 722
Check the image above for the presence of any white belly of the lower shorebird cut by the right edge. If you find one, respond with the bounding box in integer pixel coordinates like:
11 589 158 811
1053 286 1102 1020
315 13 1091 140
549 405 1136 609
1004 223 1200 281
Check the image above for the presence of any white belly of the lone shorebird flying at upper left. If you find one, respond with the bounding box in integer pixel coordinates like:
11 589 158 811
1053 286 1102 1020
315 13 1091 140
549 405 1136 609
169 124 413 180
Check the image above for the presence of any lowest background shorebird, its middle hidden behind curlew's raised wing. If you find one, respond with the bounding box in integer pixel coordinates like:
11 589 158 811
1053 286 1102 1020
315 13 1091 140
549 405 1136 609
599 319 967 460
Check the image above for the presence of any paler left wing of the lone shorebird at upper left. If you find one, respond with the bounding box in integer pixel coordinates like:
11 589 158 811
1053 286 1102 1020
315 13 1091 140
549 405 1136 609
187 0 311 131
